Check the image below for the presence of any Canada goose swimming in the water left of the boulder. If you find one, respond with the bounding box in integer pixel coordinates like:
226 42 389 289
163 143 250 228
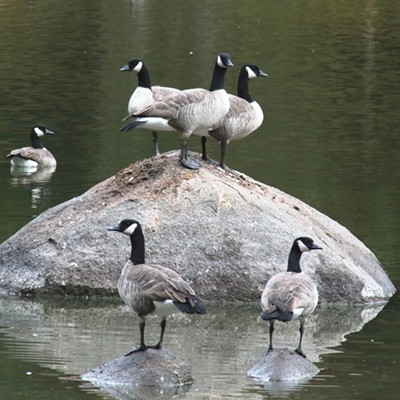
6 125 57 168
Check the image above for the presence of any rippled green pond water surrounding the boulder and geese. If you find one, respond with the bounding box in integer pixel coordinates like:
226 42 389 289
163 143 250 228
0 0 400 399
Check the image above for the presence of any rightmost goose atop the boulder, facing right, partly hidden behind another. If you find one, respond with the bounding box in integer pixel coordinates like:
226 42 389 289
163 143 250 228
202 64 268 168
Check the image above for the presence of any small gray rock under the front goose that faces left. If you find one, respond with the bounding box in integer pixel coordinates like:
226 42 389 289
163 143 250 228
81 349 193 387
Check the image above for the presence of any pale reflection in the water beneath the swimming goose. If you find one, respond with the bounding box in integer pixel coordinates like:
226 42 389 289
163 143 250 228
10 167 56 208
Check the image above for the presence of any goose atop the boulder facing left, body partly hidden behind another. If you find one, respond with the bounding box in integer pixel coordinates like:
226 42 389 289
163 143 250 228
120 58 180 155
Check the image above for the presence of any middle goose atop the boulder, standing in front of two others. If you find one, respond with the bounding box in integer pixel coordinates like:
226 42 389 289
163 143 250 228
121 53 233 169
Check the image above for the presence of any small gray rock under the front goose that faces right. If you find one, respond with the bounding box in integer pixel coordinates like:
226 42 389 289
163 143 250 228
247 348 319 382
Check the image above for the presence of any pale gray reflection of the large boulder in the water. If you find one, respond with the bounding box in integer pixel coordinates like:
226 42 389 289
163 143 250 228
0 298 383 375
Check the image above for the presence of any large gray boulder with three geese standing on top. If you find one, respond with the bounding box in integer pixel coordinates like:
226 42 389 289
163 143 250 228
0 152 395 303
